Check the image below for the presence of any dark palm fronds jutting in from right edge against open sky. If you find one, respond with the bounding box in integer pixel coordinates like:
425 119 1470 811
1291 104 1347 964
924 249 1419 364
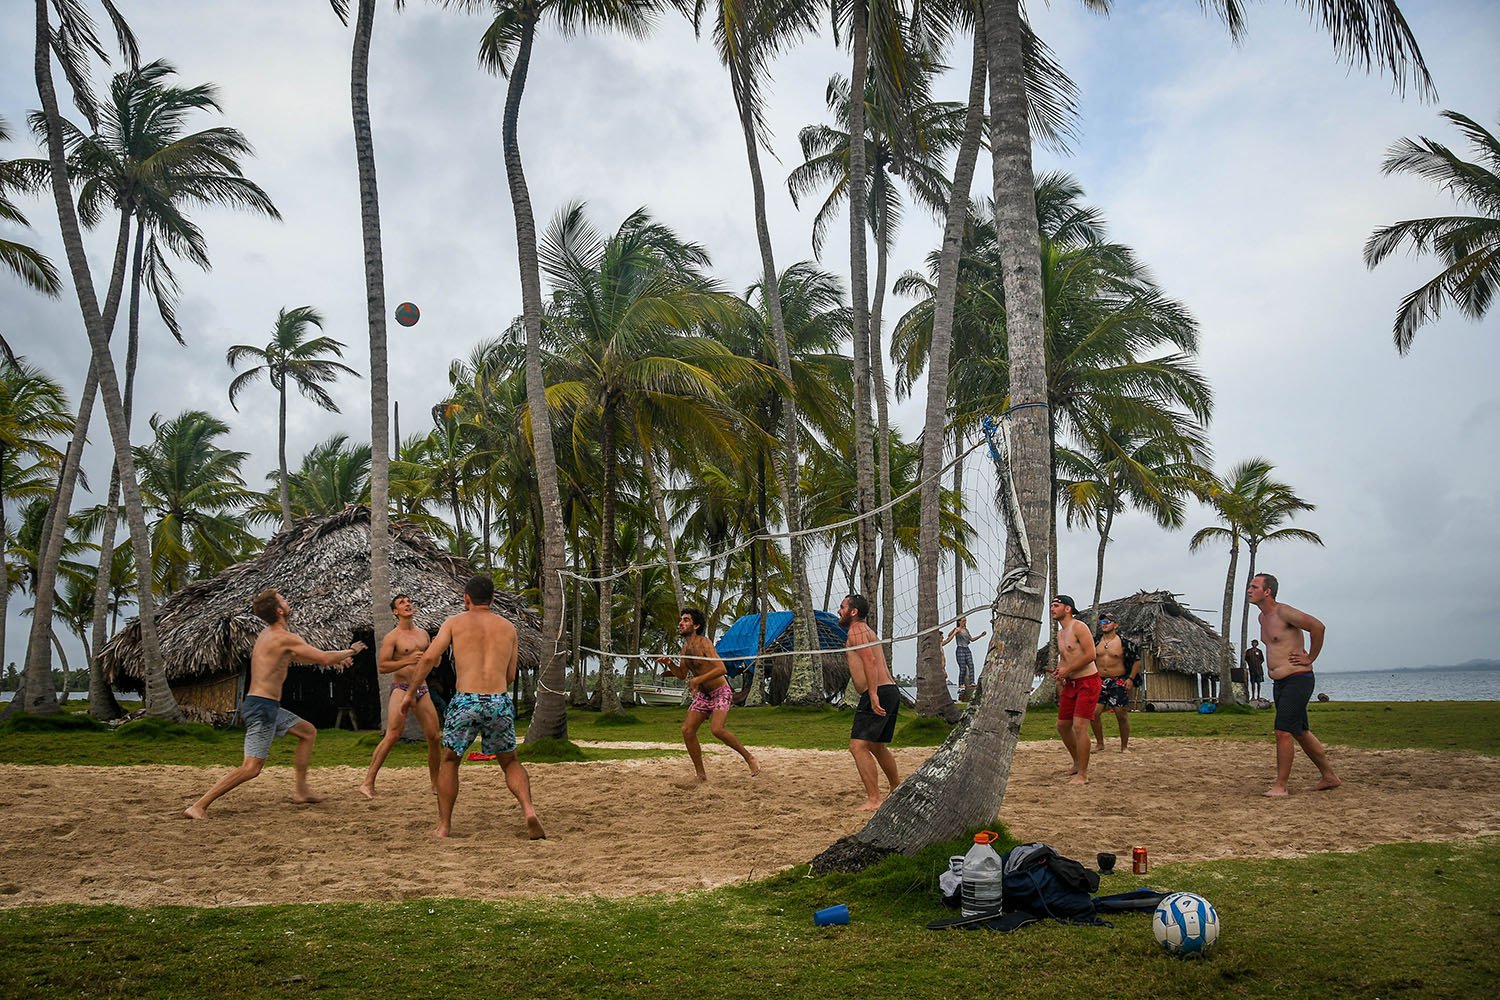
1365 111 1500 354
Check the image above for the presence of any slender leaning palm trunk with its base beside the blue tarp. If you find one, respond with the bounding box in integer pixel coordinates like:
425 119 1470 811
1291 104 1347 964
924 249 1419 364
729 58 822 705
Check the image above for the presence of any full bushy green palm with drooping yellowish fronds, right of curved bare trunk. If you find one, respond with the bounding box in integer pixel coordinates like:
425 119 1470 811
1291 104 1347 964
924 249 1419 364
534 205 765 712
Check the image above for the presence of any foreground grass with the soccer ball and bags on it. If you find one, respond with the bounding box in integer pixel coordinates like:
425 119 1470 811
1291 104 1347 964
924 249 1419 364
0 838 1500 1000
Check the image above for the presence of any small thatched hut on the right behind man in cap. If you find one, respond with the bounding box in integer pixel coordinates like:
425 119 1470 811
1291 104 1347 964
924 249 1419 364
1034 591 1224 711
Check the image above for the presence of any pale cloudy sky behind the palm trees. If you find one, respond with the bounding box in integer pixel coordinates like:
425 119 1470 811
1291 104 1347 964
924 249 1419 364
0 0 1500 680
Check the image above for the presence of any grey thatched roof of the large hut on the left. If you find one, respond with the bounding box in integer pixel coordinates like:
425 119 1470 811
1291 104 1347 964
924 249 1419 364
99 507 542 687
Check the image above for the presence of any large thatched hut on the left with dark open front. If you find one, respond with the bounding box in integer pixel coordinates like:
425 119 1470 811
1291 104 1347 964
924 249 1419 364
99 507 542 729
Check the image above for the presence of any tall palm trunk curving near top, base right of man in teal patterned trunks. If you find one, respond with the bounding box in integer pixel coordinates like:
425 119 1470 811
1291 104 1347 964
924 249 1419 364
501 13 567 742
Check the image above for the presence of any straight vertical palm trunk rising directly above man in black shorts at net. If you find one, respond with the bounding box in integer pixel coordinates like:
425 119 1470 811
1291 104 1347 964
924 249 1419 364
848 0 879 595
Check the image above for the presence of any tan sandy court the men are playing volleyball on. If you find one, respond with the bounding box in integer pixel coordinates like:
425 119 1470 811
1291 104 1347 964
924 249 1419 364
0 739 1500 907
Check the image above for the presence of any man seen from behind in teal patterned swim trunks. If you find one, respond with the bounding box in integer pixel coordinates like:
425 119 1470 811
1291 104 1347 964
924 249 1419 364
402 576 546 840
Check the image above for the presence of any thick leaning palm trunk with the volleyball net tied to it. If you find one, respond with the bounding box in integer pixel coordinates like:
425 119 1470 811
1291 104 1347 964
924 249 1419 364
815 0 1052 868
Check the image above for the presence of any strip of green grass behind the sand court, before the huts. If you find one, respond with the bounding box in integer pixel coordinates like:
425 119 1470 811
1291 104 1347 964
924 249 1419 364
0 702 1500 768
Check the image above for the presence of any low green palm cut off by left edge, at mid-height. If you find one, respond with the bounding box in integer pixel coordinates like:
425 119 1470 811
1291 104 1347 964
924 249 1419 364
0 358 74 704
